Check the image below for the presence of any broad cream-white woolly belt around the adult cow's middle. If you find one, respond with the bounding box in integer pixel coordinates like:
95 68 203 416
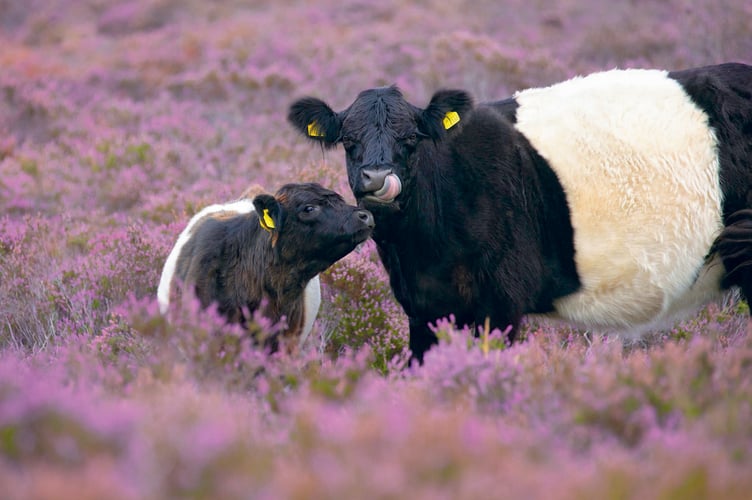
515 69 723 329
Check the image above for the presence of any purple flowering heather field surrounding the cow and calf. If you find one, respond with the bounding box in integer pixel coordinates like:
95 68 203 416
0 0 752 500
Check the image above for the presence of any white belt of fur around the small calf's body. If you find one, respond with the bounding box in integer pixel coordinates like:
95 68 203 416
157 198 321 345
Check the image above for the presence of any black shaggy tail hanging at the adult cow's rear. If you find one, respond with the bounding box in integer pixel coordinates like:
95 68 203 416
712 209 752 315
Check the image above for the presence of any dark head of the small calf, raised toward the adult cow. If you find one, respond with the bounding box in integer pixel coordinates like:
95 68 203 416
253 183 374 276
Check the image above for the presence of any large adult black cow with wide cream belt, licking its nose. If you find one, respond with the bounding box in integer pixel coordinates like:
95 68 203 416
288 63 752 360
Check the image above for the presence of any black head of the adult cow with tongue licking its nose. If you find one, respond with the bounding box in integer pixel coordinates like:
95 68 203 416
287 86 473 206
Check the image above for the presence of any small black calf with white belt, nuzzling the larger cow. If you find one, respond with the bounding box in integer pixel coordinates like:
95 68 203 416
157 183 374 346
